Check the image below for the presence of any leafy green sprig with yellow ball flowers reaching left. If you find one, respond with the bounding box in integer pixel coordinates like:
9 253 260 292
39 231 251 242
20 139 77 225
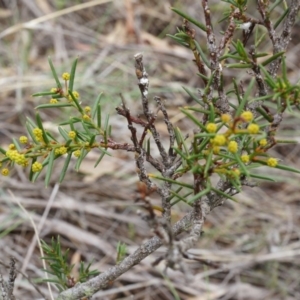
0 58 111 186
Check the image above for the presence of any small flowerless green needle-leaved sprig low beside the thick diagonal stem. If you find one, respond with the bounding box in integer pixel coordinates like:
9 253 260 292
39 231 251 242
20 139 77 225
41 237 100 291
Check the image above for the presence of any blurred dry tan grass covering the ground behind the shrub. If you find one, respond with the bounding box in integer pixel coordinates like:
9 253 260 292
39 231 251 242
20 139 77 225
0 0 300 300
